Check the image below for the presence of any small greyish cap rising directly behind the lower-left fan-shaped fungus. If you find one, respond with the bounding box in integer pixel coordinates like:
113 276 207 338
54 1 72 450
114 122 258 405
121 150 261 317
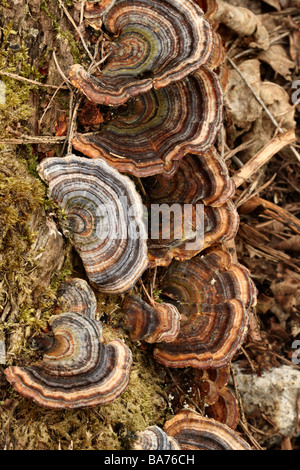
55 278 97 318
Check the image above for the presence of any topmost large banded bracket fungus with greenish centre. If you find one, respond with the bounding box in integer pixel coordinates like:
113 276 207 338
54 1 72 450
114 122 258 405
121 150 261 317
70 0 214 106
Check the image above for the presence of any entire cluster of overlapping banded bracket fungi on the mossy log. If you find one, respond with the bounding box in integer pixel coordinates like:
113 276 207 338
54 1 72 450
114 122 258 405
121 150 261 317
5 0 256 450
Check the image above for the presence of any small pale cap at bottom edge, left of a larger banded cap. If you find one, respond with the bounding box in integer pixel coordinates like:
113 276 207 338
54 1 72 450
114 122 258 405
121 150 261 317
133 426 180 450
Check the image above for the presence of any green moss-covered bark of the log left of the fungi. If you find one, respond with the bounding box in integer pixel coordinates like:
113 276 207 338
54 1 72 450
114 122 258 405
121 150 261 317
0 0 167 449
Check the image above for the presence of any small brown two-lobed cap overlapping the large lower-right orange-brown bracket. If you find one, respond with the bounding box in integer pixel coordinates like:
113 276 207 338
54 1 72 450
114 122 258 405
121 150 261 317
122 295 180 343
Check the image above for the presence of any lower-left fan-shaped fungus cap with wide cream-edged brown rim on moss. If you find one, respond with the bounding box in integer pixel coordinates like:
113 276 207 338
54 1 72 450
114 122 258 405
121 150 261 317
4 312 132 409
